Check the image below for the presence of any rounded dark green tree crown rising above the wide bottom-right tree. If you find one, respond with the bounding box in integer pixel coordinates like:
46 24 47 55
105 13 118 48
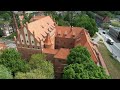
67 46 91 64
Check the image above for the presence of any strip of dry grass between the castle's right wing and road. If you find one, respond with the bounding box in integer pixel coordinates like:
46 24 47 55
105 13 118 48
98 42 120 79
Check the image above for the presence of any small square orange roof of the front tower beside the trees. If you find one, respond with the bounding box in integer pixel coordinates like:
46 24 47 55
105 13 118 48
54 48 70 60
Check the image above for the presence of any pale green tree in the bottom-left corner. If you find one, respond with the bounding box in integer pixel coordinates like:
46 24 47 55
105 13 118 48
0 65 13 79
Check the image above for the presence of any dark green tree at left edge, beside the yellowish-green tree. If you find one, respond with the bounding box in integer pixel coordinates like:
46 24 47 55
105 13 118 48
0 48 30 76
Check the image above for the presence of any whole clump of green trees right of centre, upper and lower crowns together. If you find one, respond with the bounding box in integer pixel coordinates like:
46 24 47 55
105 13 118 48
63 46 110 79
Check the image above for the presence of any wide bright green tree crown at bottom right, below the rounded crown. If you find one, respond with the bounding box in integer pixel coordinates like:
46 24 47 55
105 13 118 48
63 60 110 79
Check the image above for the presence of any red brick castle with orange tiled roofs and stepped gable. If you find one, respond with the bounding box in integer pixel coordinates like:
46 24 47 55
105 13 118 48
14 16 109 78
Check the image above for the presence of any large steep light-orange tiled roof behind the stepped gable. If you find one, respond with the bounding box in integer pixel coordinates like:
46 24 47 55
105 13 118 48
27 16 56 41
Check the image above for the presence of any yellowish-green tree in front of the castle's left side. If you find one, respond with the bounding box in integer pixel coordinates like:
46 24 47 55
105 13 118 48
15 54 54 79
